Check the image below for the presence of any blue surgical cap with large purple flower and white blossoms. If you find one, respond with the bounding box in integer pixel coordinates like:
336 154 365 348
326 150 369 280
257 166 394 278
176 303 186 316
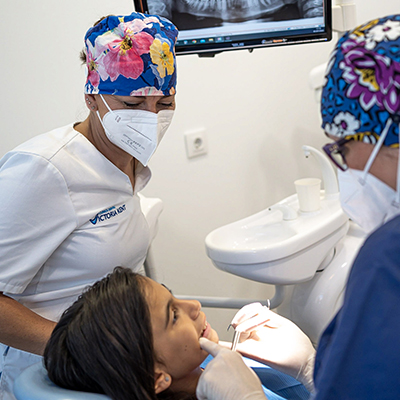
321 15 400 147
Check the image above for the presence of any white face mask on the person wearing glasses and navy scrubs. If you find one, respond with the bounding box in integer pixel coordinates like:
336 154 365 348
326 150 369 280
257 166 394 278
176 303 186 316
338 118 400 233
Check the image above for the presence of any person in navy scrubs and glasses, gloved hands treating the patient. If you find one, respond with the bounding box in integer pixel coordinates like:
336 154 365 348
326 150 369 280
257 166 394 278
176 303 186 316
197 15 400 400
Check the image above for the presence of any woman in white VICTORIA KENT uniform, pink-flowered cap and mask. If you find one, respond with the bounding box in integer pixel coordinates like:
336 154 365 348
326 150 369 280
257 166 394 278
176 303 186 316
0 13 178 400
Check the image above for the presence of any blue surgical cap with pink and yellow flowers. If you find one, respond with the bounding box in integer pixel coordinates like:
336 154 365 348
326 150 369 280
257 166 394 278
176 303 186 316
85 12 178 96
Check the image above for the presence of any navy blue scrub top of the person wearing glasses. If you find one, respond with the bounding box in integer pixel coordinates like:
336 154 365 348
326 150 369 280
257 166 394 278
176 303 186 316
314 217 400 400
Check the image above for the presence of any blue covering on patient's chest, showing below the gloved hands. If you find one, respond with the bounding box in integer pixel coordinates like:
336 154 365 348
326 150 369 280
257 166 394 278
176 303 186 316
201 356 310 400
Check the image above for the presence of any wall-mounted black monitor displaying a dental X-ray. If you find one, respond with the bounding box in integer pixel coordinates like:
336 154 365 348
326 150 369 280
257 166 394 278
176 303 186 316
134 0 332 56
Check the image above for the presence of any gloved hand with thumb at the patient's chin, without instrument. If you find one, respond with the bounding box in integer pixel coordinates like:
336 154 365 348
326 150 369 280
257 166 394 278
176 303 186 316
196 338 266 400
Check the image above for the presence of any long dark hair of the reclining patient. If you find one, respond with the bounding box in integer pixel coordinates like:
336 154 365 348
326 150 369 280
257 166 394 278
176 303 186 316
44 267 192 400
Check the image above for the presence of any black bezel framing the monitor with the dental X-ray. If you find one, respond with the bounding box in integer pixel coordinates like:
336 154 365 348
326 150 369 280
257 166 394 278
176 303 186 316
133 0 332 57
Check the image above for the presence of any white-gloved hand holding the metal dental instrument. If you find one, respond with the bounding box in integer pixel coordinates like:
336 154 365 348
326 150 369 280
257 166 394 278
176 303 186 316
231 303 315 391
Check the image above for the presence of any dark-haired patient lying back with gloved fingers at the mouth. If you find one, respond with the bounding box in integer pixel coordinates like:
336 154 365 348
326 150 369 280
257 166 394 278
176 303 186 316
44 267 308 400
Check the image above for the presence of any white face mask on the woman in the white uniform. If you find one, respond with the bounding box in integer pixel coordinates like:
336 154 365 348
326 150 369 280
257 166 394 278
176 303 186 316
97 95 174 166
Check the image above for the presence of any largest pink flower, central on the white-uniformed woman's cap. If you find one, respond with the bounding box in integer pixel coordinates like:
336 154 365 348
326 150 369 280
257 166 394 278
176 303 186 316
103 23 153 81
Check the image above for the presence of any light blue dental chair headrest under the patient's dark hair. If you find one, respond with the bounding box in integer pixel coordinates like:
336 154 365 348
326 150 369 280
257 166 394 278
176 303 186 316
14 362 111 400
